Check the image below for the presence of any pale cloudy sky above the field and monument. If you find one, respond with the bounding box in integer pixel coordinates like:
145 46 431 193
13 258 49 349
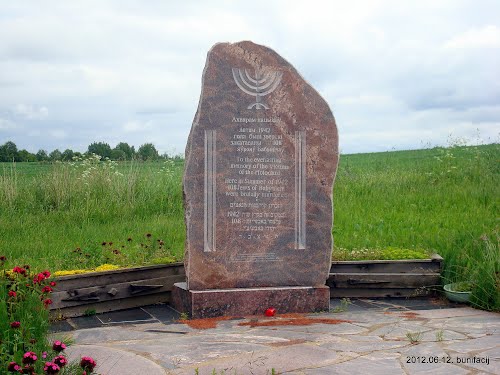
0 0 500 154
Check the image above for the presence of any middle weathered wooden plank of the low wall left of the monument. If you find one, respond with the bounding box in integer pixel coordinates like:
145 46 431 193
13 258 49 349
50 275 185 310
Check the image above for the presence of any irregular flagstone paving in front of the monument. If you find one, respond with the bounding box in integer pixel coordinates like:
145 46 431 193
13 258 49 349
53 299 500 375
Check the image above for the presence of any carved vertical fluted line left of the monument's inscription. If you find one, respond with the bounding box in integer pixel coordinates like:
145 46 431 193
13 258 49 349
203 130 217 252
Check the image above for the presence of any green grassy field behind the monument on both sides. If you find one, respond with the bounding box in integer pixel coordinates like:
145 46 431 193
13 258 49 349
0 144 500 308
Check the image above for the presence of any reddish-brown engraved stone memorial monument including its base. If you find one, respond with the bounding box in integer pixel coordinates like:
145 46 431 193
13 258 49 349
172 41 338 318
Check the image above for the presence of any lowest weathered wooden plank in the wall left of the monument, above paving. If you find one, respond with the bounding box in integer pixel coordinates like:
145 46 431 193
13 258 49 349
50 292 170 319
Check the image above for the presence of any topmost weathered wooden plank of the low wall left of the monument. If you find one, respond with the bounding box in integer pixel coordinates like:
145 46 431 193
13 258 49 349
54 263 185 291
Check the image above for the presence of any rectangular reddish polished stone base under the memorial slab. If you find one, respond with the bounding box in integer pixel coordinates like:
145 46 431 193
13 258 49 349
172 283 330 319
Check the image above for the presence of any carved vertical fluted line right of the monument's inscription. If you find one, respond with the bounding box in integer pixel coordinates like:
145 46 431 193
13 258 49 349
295 131 306 250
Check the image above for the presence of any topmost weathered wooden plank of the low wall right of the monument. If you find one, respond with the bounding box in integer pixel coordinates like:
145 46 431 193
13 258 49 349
330 259 441 273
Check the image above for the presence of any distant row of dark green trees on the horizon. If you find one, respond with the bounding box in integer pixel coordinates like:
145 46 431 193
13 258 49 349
0 141 178 162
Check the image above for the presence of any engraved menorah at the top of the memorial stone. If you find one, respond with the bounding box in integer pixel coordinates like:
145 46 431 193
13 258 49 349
233 68 283 109
